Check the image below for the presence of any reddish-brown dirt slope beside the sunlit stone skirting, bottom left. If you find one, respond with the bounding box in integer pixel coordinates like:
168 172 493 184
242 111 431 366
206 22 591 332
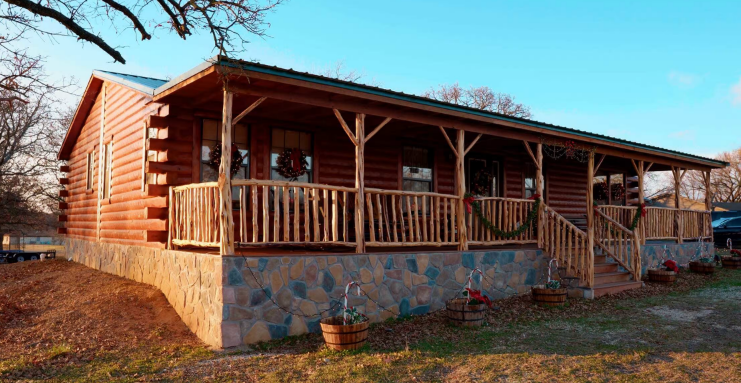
0 259 202 378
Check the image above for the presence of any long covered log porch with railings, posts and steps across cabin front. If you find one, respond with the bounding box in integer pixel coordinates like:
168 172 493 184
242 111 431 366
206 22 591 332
146 58 712 287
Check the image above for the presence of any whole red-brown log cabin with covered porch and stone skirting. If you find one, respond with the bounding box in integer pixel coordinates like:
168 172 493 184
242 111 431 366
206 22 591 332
59 56 727 347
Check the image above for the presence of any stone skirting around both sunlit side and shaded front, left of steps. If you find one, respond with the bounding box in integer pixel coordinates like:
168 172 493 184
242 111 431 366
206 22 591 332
65 239 547 348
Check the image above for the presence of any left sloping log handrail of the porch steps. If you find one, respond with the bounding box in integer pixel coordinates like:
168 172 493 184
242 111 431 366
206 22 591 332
541 206 594 287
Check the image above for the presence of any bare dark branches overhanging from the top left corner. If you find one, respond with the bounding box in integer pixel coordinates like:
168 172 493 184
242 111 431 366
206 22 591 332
0 0 284 101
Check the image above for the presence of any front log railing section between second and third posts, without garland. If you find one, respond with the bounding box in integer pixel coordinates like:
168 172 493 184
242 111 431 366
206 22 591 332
365 188 460 247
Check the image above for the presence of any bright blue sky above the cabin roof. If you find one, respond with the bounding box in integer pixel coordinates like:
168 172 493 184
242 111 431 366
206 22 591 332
32 0 741 156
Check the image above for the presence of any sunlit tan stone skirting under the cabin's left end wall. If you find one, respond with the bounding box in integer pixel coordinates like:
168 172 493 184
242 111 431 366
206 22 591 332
65 238 224 348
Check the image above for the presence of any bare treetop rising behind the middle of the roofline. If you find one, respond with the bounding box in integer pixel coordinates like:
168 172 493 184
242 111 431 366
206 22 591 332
423 83 532 118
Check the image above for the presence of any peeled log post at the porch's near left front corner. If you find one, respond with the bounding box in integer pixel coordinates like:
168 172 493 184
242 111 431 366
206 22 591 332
219 87 234 255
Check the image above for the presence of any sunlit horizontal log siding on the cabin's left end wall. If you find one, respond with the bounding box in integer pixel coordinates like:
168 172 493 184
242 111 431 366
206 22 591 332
65 83 162 246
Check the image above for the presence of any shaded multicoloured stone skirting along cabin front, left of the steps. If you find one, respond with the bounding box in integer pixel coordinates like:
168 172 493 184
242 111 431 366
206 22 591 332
222 250 547 347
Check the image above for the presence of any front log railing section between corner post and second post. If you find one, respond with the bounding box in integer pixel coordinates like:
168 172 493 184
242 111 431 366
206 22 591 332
232 180 357 246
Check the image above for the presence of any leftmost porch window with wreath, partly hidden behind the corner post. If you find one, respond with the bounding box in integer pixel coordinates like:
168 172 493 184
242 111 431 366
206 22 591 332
201 120 250 184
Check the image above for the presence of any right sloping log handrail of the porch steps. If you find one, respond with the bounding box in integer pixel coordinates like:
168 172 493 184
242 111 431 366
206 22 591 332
594 209 641 281
